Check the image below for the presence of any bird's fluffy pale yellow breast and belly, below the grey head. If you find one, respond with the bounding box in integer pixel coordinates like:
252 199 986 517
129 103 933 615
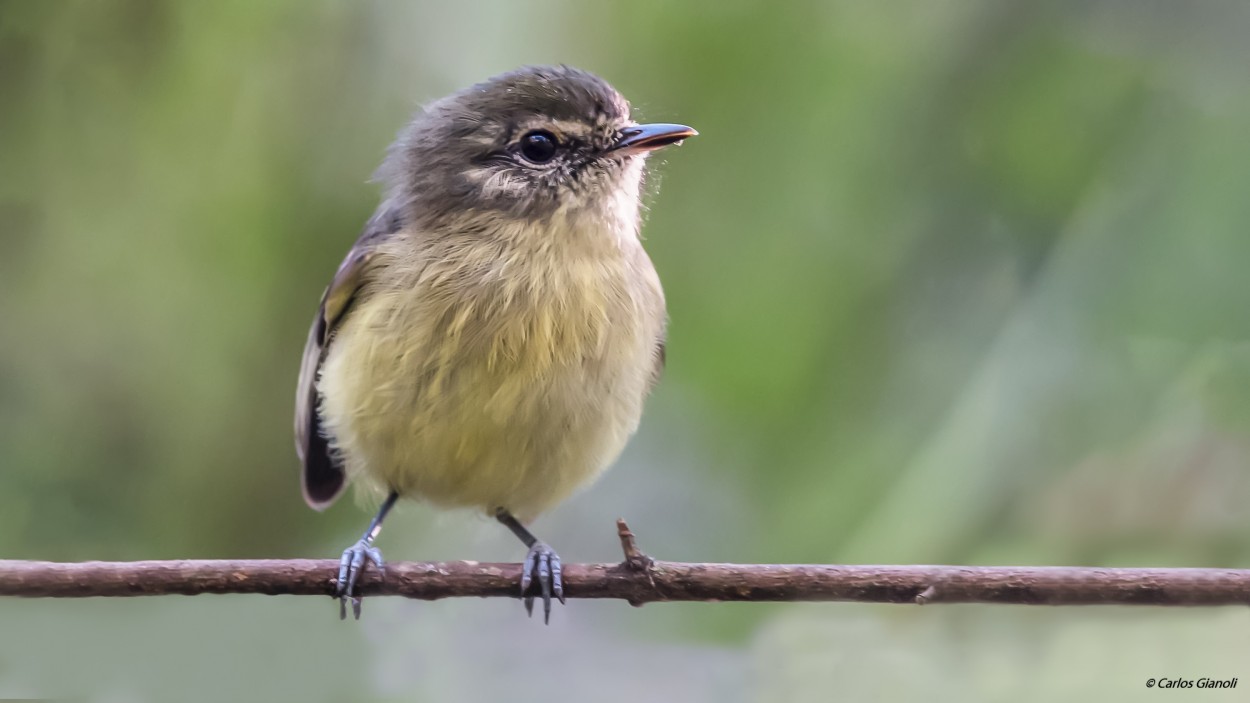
318 205 665 519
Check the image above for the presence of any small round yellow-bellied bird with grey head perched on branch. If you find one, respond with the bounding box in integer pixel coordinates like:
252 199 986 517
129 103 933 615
295 66 696 622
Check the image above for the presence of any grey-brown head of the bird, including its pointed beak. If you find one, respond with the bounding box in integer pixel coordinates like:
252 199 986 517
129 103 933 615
380 66 696 231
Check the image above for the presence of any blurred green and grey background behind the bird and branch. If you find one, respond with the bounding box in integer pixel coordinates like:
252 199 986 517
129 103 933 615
0 0 1250 702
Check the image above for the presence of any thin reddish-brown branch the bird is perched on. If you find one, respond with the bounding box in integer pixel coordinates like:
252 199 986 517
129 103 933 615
0 520 1250 605
